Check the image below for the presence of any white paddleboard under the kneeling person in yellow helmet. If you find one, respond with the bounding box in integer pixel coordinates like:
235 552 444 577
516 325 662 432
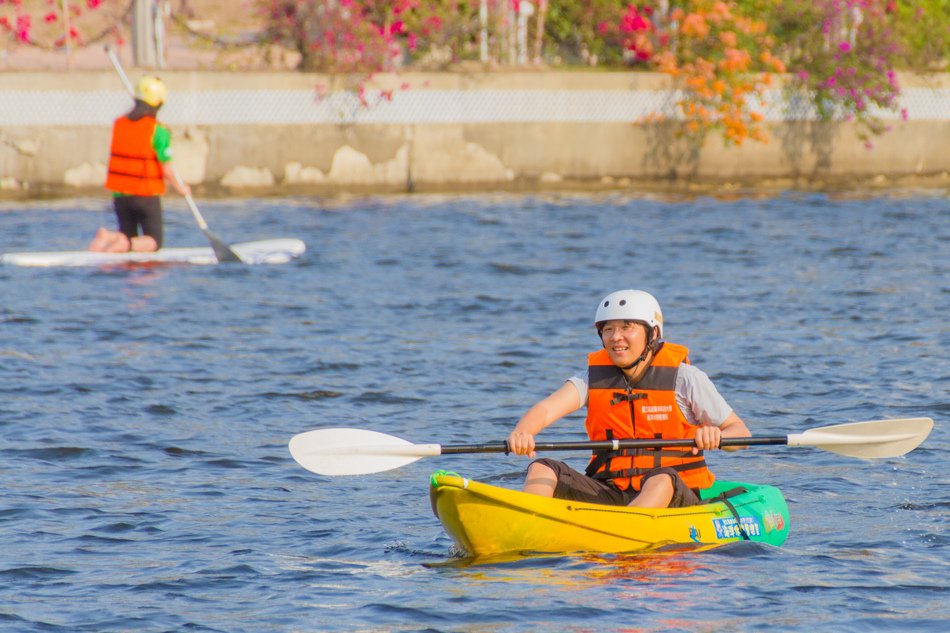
0 238 307 266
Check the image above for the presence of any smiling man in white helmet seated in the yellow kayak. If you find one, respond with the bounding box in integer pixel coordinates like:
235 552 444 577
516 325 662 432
508 290 751 508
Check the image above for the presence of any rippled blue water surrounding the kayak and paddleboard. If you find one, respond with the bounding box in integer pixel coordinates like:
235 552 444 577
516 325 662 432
0 192 950 633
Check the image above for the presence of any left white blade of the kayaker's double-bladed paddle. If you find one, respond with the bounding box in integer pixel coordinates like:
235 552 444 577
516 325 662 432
289 428 442 477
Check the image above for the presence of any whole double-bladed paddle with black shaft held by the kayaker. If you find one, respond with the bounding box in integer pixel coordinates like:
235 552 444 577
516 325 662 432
290 418 933 476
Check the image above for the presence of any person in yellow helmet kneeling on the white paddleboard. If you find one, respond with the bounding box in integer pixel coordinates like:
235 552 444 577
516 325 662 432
89 76 191 253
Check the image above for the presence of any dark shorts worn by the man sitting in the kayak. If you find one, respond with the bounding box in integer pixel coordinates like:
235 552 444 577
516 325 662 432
535 459 702 508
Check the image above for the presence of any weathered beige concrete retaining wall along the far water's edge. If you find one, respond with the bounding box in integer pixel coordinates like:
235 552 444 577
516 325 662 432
0 71 950 197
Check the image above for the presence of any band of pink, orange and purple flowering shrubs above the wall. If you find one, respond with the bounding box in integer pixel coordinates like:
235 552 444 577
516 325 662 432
0 0 950 144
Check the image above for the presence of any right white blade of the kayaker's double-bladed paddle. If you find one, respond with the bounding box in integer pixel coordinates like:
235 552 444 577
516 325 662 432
788 418 934 458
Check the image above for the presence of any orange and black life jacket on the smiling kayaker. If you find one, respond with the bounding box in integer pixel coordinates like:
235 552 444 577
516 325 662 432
586 343 715 490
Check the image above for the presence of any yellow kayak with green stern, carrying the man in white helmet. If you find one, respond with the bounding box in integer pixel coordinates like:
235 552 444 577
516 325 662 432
429 472 789 558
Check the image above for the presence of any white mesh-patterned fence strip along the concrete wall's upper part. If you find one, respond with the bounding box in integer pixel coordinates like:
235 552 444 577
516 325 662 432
0 87 950 126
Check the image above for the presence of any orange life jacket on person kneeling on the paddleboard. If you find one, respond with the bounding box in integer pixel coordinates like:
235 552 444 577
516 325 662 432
106 116 165 196
